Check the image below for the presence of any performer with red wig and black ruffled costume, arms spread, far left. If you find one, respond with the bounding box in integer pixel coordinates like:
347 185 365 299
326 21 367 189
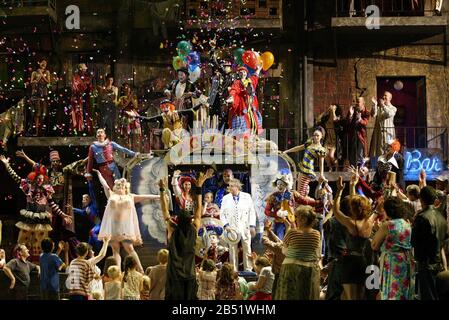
0 156 72 261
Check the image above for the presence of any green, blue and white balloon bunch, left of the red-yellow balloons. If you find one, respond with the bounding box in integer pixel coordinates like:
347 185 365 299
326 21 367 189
172 40 201 82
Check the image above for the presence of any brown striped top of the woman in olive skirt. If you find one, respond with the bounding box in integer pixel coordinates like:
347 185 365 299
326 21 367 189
284 230 321 261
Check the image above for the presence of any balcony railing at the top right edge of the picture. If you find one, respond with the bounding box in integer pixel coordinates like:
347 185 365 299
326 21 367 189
335 0 434 17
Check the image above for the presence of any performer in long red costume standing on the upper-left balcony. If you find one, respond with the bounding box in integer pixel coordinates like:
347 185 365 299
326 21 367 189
71 63 92 133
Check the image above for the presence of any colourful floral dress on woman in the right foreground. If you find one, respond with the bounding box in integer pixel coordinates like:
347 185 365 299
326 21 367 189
380 219 414 300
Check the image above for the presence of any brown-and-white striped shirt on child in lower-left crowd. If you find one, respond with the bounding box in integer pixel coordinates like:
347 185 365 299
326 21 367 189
66 258 95 296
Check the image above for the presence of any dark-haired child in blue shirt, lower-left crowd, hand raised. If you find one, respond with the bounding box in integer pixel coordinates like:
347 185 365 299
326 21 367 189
39 238 68 300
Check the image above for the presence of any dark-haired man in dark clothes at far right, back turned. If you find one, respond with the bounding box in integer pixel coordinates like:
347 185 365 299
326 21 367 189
412 186 448 300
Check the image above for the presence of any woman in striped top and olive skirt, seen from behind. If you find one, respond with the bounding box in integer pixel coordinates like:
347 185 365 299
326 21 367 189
274 206 321 300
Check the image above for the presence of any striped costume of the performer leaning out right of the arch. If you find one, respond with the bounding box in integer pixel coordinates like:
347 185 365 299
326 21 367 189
298 140 326 197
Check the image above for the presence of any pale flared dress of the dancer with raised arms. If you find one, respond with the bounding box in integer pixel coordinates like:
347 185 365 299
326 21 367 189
98 192 142 245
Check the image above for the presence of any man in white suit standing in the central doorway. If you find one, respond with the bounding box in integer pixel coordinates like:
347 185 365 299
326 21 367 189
220 179 256 271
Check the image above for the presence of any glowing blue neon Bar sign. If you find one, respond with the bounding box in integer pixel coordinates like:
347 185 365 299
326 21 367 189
404 149 443 180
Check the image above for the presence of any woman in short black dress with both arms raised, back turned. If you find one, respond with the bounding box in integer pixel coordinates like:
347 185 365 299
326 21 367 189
334 175 377 300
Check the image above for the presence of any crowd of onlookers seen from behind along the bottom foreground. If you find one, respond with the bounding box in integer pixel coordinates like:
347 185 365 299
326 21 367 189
0 171 449 300
